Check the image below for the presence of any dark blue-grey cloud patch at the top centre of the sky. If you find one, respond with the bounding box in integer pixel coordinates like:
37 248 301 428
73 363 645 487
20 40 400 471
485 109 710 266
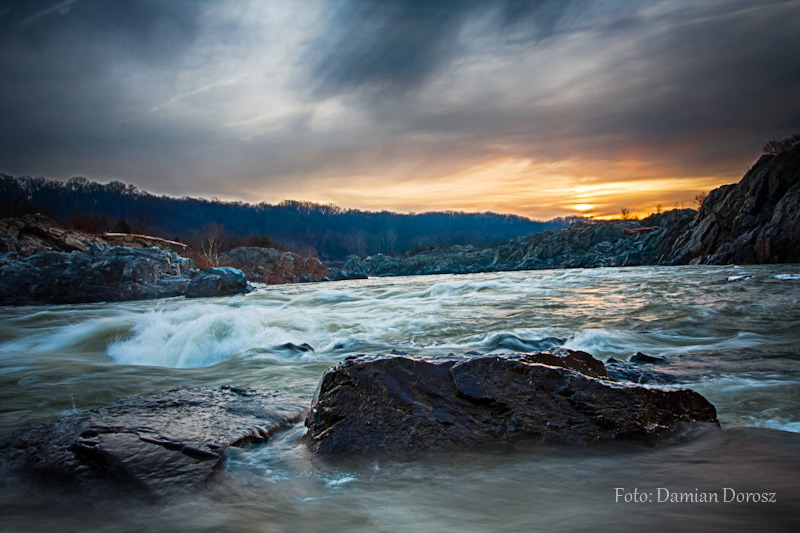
308 0 608 95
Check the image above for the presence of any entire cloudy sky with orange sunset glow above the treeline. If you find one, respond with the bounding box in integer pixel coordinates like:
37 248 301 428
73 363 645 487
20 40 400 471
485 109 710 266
0 0 800 219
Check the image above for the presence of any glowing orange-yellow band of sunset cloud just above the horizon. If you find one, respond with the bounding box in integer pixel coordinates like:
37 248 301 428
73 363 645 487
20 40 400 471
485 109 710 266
248 157 739 219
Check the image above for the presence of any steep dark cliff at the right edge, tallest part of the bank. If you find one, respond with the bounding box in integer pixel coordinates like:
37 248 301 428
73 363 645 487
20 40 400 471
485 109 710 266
673 146 800 264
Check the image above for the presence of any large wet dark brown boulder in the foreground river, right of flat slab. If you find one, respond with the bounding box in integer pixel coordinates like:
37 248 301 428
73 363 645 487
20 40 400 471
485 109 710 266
305 356 717 455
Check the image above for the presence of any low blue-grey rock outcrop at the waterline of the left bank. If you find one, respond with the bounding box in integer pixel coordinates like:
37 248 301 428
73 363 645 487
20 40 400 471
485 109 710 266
0 244 247 305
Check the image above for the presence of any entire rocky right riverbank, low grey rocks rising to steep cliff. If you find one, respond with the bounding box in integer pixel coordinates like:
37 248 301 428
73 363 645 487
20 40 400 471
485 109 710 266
344 147 800 276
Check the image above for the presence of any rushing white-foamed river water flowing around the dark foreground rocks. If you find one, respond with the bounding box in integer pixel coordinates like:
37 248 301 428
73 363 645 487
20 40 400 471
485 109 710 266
0 265 800 531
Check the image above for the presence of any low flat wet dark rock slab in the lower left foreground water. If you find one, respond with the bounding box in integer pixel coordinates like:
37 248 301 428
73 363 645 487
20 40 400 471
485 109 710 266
0 386 305 499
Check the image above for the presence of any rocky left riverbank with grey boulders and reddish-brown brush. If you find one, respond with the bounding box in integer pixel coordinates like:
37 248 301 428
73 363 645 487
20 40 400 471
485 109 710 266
0 214 366 305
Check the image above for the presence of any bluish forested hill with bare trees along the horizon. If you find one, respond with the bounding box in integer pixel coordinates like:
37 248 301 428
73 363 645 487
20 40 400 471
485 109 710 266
0 174 571 261
